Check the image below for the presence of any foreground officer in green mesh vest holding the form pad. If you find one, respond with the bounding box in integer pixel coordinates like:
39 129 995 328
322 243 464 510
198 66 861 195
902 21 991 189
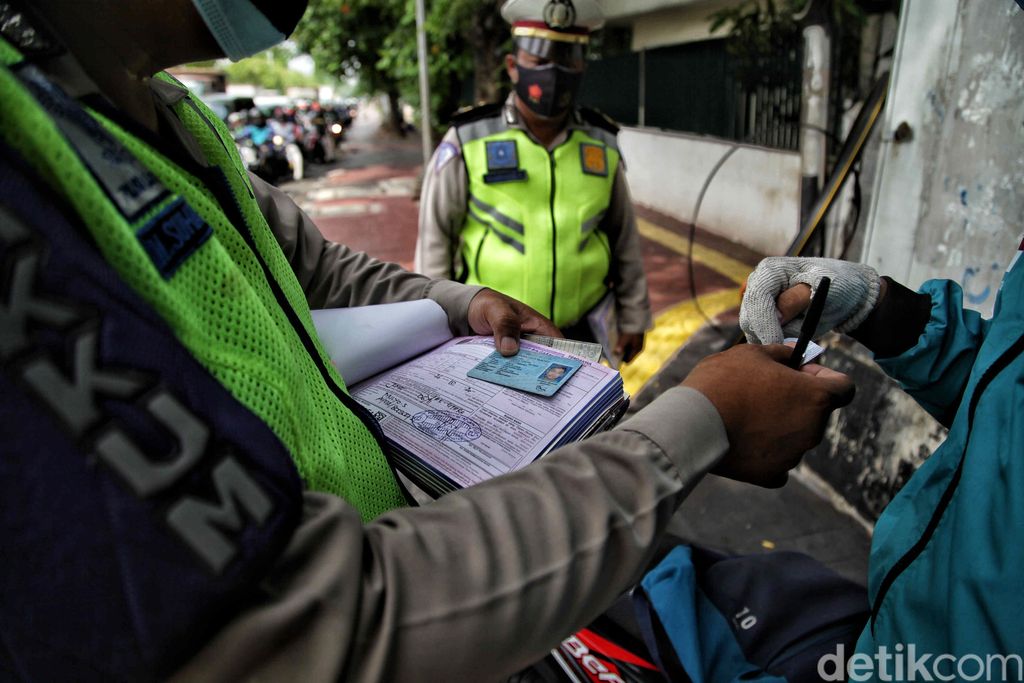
0 0 850 681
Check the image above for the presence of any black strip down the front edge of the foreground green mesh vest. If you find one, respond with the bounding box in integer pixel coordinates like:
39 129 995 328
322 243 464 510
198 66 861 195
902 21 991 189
210 164 419 507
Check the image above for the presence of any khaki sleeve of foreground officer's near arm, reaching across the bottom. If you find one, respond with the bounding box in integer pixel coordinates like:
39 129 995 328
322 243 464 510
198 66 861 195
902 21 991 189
169 388 727 682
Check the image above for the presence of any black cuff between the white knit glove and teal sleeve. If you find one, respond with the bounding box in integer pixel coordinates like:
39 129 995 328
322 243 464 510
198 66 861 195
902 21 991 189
850 276 932 358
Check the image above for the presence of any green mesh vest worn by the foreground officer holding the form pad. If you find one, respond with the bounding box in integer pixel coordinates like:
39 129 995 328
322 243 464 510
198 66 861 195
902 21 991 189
0 41 406 520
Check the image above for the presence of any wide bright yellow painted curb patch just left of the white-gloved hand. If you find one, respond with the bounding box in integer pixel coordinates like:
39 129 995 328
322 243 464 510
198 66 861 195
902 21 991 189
618 286 746 395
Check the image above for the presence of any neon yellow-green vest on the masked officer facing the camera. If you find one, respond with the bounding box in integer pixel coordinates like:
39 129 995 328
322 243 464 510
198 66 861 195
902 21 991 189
457 115 621 327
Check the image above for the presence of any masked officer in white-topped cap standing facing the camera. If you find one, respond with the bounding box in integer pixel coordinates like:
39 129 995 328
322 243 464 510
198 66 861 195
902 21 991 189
417 0 651 360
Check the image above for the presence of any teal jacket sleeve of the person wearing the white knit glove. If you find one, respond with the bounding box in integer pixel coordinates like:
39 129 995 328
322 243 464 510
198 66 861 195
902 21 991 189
877 280 991 424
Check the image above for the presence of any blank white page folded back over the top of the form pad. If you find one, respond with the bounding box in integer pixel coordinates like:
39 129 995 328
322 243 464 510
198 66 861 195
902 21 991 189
312 299 453 386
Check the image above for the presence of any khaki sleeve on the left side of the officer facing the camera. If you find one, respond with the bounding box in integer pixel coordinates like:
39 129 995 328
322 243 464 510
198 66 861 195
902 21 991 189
415 128 468 279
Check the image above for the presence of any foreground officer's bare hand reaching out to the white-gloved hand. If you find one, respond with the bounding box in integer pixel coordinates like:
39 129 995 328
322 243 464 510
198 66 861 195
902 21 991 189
683 344 855 486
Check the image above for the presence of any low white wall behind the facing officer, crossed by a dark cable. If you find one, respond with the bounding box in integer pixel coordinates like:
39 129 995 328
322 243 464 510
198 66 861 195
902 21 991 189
618 128 800 254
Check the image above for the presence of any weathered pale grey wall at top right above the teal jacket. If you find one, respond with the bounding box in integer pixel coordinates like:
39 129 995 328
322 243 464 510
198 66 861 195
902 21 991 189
864 0 1024 314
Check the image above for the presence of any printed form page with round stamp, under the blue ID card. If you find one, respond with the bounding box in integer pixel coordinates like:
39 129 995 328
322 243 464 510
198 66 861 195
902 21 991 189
351 337 616 486
